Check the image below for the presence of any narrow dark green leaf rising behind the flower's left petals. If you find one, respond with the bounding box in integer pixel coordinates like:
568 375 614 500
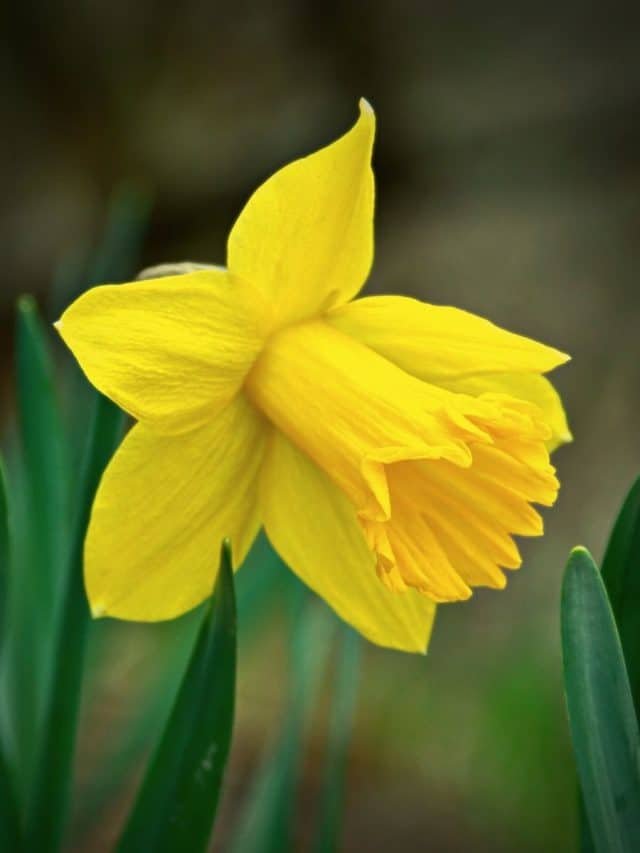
26 395 124 851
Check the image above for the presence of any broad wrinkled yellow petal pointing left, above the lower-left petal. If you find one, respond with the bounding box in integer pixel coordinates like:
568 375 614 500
57 270 262 432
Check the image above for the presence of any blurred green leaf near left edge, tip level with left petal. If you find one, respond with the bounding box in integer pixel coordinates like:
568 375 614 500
3 296 69 793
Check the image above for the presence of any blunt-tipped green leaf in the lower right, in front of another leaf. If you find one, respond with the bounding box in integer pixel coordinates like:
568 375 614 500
561 548 640 853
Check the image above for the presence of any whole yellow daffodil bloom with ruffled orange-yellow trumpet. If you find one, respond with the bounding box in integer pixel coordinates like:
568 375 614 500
58 101 570 651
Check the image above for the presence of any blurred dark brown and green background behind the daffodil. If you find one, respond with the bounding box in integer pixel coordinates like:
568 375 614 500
0 0 640 853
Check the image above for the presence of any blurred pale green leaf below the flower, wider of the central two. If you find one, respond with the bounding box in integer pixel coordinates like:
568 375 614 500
227 585 335 853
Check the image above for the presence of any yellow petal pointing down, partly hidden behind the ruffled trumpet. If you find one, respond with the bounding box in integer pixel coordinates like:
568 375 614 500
261 432 435 652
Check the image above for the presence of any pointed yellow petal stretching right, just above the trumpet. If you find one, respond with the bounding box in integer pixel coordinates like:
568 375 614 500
327 296 569 384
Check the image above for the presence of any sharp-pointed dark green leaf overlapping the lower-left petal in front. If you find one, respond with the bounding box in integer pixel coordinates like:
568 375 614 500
118 542 236 853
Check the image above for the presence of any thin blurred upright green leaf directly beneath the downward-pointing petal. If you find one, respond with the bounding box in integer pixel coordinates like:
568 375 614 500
315 625 362 853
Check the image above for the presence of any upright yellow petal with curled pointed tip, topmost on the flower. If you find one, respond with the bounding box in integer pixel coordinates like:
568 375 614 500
228 100 375 325
